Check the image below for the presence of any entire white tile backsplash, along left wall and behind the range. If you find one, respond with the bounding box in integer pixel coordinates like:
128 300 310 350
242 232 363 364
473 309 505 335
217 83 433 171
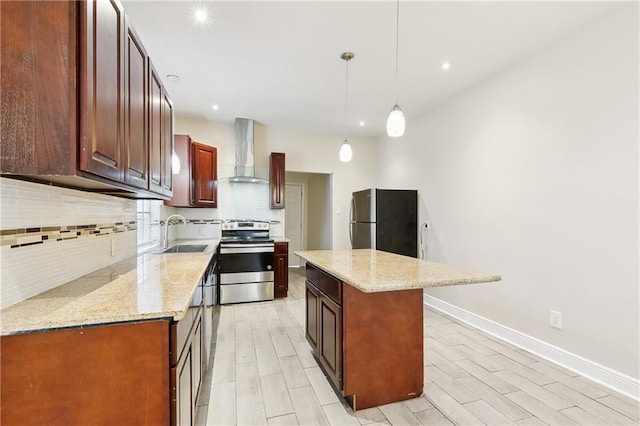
0 166 284 309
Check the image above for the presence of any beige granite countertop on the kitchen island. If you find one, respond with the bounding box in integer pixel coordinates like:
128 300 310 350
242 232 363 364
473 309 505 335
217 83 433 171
295 249 502 293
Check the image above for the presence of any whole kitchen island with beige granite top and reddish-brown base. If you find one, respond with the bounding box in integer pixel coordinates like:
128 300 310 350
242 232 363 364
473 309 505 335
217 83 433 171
295 249 501 410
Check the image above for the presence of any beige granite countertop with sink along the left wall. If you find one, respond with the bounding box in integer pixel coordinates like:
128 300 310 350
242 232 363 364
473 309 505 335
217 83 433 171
0 240 218 336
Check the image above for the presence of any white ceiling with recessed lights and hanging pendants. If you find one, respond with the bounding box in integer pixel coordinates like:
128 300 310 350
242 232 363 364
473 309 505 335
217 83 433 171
123 0 618 136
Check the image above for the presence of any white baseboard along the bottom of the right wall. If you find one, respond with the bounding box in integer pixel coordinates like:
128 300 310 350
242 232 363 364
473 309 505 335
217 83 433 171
424 294 640 401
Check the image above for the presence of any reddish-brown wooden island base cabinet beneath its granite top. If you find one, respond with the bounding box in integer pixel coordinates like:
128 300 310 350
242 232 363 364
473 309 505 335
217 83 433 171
306 263 424 410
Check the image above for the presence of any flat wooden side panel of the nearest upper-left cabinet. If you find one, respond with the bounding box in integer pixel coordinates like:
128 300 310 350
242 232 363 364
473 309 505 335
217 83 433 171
0 0 80 176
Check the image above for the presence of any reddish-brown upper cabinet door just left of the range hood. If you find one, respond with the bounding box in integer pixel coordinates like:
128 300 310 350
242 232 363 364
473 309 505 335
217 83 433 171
191 142 218 207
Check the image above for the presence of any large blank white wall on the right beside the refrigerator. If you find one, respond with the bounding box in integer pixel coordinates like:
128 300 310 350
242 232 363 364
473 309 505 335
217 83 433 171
378 3 640 378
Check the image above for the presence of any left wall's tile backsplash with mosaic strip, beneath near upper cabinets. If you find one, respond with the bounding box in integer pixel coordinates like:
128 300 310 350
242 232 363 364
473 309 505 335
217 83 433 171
0 177 136 308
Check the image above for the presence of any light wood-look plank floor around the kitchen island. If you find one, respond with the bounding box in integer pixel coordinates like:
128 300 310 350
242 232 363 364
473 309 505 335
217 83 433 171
196 270 640 425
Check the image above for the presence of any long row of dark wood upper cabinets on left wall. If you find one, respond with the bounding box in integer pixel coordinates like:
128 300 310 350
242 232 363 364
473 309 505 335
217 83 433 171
0 0 173 199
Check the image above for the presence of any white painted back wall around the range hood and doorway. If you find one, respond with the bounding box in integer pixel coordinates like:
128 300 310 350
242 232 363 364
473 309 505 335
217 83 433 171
175 116 376 249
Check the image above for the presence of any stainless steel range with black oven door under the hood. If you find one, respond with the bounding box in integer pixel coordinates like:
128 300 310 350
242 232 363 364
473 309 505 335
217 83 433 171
218 220 274 304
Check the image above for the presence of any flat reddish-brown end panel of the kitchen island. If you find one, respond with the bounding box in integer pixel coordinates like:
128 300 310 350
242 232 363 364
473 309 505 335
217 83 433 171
342 284 424 410
